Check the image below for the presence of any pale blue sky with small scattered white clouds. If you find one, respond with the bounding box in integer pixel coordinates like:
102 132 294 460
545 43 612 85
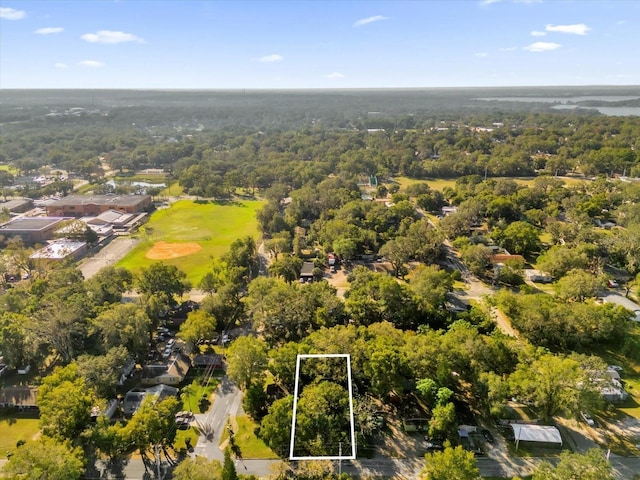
0 0 640 89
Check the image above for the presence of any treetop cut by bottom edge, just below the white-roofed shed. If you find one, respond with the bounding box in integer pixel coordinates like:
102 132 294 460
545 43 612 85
533 448 616 480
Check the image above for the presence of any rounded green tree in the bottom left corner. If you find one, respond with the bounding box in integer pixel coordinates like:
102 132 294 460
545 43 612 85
2 437 84 480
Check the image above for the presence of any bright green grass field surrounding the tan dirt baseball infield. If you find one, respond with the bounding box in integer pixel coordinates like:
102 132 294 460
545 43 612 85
118 200 263 286
